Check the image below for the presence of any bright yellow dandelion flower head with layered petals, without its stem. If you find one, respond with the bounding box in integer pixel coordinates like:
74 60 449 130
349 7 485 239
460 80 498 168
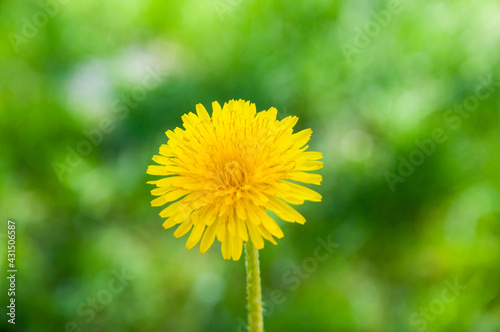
147 100 323 260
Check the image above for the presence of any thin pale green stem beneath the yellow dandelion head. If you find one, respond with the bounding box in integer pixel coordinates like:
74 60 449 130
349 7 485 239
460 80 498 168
245 240 264 332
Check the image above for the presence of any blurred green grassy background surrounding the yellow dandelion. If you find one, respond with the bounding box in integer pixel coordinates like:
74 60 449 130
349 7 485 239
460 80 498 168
0 0 500 332
